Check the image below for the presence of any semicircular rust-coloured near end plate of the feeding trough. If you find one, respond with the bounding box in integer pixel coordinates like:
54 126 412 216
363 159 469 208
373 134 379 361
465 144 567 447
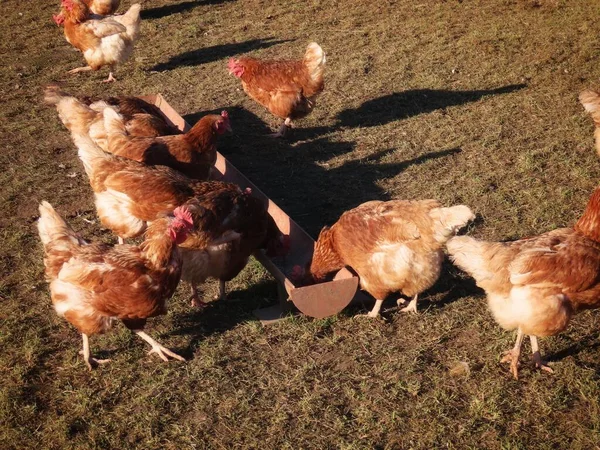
290 277 358 319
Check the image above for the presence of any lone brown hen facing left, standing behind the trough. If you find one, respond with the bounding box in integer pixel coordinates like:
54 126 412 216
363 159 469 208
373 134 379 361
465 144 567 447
228 42 326 136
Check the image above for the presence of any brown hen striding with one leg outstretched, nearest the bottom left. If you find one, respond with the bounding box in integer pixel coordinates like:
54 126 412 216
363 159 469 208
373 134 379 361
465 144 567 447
38 202 193 370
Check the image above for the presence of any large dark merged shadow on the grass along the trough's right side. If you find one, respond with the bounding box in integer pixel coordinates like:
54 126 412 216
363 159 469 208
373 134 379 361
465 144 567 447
185 106 461 237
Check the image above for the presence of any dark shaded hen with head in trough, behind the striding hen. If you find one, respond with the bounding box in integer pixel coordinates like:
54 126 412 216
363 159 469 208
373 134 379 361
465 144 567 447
181 183 289 307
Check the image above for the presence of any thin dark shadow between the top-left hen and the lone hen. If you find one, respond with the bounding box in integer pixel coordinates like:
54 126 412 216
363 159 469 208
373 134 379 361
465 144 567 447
148 38 290 72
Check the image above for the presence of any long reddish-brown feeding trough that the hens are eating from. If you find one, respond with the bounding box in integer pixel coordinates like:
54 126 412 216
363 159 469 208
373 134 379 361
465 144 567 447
140 94 360 323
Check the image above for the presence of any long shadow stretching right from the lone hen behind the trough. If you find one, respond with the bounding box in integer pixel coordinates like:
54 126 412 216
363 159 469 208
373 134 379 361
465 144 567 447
337 84 527 127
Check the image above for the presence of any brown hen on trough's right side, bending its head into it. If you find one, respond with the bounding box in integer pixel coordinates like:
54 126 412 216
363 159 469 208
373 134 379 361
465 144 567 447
293 200 474 317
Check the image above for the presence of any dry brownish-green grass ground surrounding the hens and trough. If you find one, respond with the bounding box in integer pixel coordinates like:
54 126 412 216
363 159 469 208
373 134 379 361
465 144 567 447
0 0 600 449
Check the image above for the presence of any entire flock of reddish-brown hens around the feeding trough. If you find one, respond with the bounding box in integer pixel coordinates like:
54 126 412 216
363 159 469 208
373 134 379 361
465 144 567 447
38 0 600 378
